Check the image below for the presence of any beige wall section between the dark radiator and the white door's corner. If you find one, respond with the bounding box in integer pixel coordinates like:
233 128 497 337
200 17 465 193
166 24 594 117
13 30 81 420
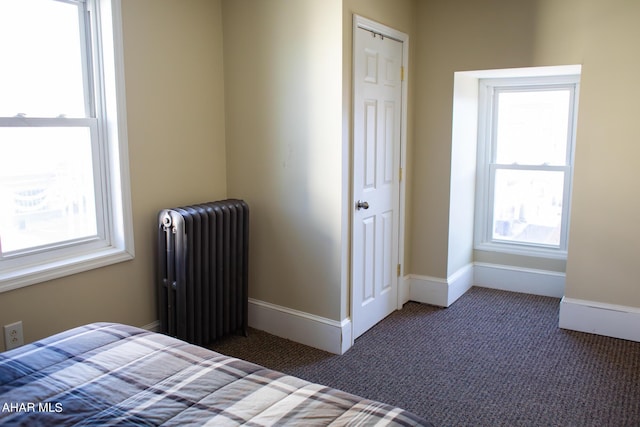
222 0 346 320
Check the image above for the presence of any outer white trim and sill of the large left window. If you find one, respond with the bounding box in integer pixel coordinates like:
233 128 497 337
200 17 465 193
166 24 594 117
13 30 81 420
0 0 135 293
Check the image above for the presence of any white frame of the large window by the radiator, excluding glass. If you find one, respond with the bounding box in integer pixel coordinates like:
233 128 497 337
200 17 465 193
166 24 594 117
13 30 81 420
0 0 135 292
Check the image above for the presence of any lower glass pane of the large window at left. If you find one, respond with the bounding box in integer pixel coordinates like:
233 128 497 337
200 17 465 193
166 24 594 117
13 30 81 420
0 127 97 253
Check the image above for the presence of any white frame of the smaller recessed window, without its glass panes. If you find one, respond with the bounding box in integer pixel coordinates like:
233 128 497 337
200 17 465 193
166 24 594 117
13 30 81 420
474 75 580 259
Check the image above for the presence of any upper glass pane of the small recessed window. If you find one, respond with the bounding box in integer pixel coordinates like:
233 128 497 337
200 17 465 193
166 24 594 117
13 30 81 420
496 89 571 166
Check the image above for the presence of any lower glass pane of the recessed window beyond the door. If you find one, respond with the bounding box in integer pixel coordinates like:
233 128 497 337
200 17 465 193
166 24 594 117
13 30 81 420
493 169 564 246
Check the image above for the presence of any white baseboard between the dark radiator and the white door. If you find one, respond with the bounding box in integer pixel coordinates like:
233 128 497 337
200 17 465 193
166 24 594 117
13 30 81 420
249 298 353 354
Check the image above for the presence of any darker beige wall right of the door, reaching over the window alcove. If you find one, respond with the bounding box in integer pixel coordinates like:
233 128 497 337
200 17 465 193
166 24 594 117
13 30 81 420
409 0 536 278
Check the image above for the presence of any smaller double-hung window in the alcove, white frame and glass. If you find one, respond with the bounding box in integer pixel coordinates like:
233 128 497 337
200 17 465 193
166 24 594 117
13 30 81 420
476 76 579 258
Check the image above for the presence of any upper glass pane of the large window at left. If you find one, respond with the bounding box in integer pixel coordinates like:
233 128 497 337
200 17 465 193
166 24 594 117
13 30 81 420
0 0 86 117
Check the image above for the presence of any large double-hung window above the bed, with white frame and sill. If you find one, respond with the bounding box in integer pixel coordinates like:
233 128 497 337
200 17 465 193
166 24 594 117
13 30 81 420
0 0 133 291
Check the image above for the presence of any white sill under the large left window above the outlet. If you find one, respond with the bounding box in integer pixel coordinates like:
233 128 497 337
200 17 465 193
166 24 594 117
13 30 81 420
0 247 134 293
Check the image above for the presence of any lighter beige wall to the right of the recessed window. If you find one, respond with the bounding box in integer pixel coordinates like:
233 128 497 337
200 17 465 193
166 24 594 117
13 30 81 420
536 0 640 307
